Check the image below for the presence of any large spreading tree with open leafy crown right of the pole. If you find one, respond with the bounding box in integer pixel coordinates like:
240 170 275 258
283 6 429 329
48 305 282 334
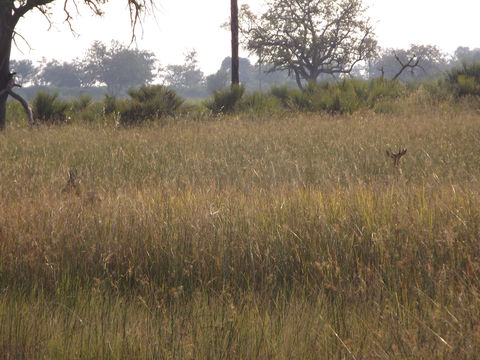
240 0 376 88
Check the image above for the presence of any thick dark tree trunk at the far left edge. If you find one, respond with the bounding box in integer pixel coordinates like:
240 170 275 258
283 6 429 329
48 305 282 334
0 9 14 130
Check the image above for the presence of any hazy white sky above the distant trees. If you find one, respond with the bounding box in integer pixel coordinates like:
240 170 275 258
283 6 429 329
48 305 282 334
12 0 480 74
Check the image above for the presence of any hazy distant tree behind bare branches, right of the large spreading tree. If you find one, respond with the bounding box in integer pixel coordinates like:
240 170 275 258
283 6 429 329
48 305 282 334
367 45 448 81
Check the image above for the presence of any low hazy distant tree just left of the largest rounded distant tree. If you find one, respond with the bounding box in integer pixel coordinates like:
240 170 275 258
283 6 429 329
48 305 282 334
38 60 82 88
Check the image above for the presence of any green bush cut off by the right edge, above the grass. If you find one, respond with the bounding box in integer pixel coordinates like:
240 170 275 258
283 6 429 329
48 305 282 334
447 61 480 97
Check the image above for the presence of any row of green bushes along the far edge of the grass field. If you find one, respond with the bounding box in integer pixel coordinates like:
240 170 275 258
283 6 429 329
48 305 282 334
6 62 480 125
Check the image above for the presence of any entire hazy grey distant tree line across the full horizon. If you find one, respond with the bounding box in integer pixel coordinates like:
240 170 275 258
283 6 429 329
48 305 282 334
11 42 480 98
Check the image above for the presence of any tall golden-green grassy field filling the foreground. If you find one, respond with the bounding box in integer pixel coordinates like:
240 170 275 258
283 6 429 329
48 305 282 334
0 97 480 359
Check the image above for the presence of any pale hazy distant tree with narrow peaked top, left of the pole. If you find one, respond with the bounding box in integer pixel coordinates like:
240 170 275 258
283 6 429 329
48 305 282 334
163 50 205 97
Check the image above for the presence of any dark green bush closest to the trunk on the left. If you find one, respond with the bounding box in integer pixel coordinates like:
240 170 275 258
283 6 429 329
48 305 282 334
32 91 69 124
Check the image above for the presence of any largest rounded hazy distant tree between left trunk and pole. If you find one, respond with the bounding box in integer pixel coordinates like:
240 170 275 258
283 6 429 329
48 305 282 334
83 41 156 95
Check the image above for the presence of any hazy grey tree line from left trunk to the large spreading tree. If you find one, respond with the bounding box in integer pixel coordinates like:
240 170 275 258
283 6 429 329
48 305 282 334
10 41 293 98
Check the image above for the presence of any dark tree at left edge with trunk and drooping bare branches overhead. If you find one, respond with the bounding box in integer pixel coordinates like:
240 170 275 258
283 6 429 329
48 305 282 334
0 0 154 129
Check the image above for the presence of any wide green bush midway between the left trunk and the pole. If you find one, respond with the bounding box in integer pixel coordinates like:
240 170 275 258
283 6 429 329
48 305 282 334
120 85 183 125
